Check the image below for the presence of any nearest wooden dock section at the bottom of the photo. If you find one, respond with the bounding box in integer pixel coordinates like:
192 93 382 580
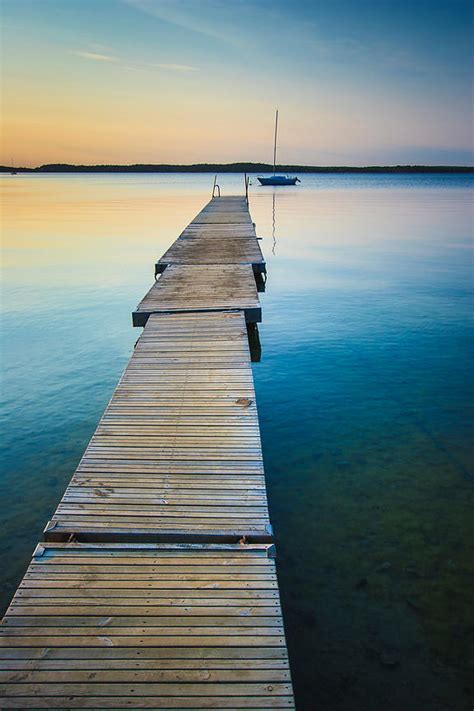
0 543 294 709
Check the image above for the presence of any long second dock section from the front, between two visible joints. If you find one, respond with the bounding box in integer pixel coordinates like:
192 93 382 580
46 312 271 544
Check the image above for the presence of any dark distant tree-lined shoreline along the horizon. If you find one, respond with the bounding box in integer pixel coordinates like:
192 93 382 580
0 163 474 173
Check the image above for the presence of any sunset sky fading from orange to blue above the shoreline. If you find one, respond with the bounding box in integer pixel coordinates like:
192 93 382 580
0 0 474 166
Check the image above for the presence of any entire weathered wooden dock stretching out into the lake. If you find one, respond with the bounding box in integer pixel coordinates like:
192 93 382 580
0 197 294 709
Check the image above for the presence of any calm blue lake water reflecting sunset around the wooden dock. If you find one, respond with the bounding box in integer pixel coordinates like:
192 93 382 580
0 174 474 711
